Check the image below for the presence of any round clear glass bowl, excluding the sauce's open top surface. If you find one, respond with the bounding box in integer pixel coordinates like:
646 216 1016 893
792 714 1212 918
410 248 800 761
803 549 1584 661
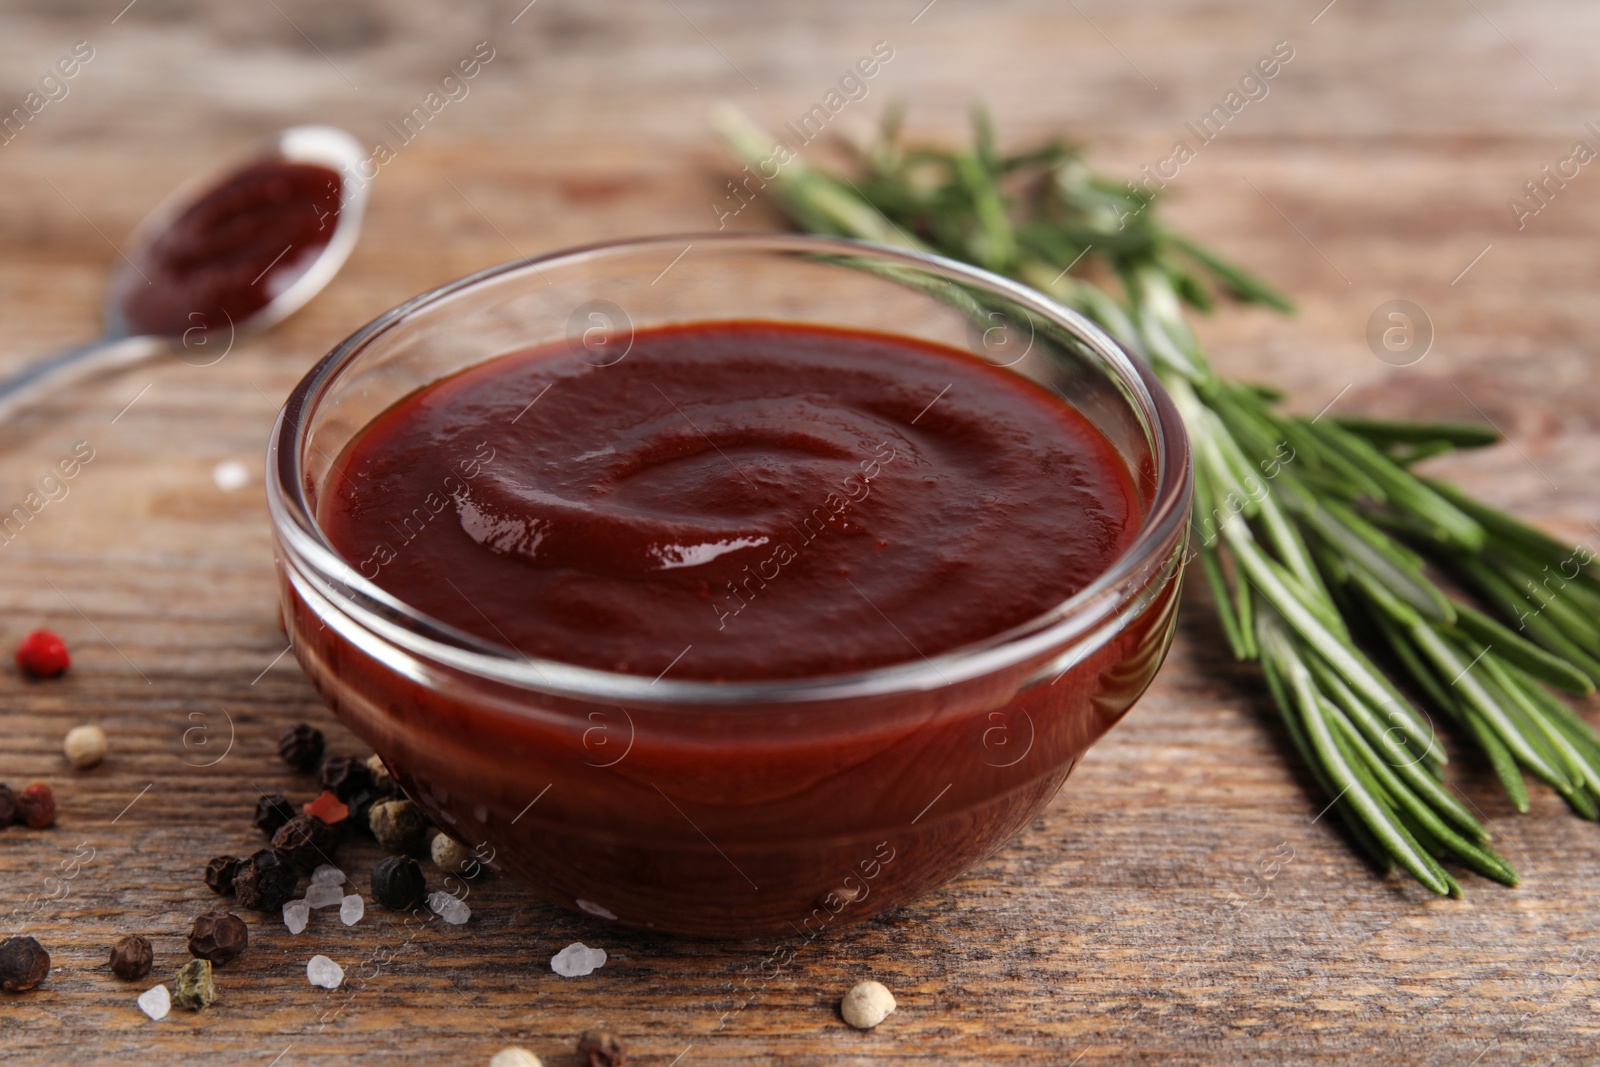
267 234 1190 936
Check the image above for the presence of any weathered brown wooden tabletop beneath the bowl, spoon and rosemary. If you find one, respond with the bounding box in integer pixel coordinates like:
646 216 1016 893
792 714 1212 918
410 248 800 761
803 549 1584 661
0 0 1600 1067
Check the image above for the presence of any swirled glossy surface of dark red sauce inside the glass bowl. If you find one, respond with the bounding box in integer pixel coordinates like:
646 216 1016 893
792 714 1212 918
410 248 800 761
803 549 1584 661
320 322 1139 680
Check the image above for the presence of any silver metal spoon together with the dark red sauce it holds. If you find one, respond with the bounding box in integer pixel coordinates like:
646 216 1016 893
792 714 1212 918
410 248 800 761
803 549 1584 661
0 126 366 418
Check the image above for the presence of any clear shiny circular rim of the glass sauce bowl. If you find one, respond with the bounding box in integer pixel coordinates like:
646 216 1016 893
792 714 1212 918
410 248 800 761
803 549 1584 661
266 232 1192 709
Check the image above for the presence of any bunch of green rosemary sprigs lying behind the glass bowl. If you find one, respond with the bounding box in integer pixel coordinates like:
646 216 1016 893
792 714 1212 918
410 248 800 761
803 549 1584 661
718 110 1600 896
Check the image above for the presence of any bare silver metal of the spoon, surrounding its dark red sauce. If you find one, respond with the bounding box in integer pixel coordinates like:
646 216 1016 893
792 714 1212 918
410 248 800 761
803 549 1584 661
0 126 366 419
